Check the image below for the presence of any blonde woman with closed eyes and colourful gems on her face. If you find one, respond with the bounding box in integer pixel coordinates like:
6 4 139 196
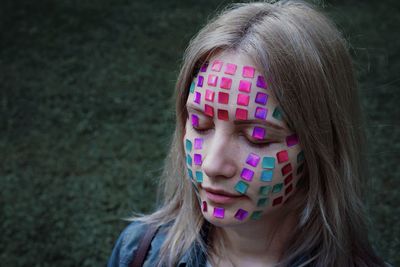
109 1 384 266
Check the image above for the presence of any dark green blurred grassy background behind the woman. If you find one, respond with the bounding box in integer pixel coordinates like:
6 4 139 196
0 0 400 267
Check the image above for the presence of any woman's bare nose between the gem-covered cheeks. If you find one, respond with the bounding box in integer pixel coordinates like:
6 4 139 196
202 131 237 178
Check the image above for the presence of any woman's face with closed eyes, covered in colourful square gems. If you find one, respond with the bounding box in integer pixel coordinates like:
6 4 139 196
183 52 303 225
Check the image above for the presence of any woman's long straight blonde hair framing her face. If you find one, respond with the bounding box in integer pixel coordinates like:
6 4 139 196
131 1 383 266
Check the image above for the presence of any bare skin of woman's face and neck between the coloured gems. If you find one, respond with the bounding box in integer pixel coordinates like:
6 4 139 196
184 51 302 266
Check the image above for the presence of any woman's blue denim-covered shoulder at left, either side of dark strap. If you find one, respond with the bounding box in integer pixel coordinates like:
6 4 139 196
108 221 168 267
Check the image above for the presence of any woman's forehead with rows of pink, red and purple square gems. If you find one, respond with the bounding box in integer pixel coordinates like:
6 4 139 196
187 52 285 126
